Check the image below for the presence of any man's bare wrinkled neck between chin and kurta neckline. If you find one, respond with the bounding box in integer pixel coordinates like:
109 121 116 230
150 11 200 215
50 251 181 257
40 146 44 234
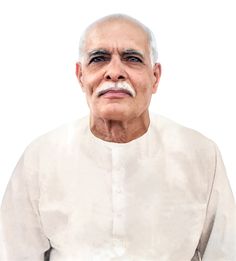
90 113 150 143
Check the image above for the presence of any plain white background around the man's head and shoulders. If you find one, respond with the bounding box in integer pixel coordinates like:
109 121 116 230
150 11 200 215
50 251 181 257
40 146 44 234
0 0 236 199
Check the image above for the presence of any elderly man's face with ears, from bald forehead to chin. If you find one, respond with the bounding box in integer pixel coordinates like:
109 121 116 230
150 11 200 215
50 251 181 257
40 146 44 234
76 20 160 120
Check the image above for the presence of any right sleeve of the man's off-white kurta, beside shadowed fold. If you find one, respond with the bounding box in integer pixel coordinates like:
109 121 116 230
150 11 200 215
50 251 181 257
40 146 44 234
198 143 236 261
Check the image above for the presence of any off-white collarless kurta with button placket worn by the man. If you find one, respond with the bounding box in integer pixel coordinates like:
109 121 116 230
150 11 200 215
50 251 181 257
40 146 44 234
1 115 236 261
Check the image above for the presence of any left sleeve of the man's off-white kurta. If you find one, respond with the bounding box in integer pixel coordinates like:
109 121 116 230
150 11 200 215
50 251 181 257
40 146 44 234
1 153 50 261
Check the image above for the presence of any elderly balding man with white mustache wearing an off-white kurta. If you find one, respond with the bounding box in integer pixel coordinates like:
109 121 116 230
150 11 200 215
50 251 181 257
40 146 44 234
2 15 236 261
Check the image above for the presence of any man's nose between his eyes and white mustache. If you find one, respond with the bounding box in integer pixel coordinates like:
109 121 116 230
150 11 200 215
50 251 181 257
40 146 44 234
104 58 127 82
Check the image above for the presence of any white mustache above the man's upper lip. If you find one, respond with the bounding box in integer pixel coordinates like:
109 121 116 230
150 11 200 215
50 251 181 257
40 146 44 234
95 82 136 97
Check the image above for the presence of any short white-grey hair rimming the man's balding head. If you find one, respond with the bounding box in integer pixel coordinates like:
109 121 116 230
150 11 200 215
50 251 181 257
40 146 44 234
79 14 158 64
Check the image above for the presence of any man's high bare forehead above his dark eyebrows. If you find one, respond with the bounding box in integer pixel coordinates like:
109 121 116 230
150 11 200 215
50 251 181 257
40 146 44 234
84 20 149 53
